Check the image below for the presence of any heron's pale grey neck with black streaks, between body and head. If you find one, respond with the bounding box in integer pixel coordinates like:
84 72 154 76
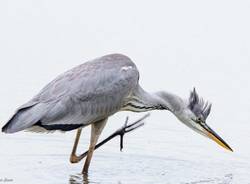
124 87 184 113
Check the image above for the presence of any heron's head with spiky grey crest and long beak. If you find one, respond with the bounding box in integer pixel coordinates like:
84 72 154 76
177 88 233 151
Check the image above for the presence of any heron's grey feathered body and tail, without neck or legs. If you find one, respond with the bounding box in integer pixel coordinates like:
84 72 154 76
3 54 139 133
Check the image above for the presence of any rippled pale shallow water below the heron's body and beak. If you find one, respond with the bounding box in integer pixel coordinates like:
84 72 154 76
0 114 250 184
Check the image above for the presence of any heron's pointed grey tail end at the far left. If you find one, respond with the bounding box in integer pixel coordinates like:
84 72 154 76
2 104 43 133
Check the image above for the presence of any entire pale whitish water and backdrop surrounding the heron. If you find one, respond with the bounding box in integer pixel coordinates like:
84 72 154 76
0 0 250 184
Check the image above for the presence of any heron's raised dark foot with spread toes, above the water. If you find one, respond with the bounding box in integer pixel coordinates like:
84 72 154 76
115 114 150 151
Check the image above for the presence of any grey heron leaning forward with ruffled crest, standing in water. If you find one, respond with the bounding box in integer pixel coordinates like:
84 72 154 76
2 54 233 172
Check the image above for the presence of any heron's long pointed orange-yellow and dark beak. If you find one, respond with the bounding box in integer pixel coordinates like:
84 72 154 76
201 123 233 152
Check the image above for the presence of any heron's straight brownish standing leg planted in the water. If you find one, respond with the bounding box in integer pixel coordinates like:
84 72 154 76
82 119 108 173
